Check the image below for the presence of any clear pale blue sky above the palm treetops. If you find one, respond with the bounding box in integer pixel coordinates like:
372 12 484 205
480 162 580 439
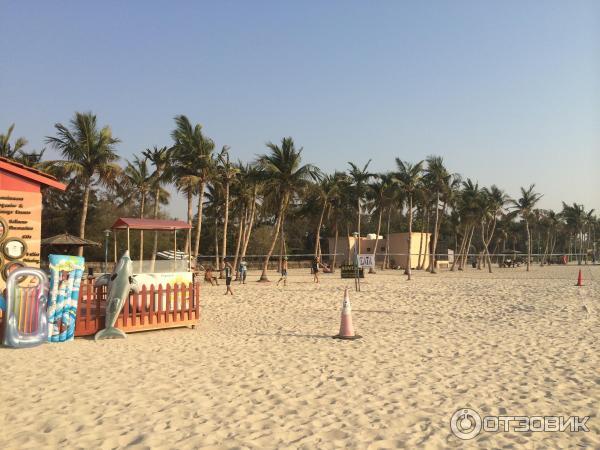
0 0 600 216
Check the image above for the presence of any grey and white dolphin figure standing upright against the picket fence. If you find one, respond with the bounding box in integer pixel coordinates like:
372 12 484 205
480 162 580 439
94 250 138 340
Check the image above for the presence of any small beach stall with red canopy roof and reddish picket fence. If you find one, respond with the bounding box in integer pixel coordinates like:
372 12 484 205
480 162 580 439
75 217 200 336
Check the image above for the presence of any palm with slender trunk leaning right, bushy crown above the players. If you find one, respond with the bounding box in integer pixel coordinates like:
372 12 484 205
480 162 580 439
257 137 318 281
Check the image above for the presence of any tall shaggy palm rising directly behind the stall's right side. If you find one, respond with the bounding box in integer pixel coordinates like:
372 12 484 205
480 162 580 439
171 115 214 254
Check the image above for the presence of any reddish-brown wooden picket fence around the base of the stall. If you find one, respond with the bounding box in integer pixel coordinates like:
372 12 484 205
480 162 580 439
75 278 200 336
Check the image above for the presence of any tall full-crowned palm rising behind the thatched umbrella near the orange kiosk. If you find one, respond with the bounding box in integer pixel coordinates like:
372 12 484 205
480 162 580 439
46 112 121 256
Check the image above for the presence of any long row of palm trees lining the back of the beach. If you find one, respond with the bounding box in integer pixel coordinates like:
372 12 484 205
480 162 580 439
0 113 598 280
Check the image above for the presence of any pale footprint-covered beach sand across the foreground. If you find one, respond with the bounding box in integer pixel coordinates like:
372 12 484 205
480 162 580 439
0 266 600 449
